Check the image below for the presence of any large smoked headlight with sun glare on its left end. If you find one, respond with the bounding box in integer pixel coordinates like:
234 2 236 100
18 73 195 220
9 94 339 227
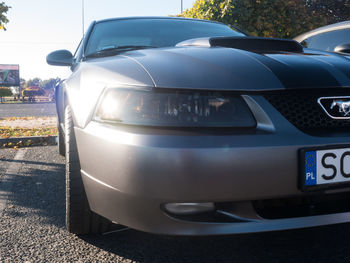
93 89 256 128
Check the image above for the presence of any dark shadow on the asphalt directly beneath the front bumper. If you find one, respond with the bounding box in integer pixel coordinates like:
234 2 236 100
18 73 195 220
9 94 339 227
78 224 350 262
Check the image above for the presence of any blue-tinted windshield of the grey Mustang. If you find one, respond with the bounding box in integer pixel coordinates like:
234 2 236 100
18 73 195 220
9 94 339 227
85 18 244 55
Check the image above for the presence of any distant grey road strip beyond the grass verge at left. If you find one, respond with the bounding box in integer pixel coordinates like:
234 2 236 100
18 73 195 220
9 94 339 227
0 102 56 118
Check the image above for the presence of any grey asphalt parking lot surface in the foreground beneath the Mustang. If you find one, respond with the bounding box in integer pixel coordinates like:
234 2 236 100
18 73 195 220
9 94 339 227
0 146 350 263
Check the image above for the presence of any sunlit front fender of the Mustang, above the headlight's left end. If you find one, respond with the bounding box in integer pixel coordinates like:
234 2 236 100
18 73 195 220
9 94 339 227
63 56 154 128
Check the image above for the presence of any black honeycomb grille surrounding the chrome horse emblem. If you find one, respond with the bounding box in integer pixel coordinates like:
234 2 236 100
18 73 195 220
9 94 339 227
264 90 350 135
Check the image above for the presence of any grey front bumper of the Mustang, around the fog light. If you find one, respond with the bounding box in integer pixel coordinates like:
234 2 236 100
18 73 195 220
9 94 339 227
75 96 350 235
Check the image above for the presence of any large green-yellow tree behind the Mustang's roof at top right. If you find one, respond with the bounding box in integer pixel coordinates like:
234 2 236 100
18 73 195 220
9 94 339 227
179 0 350 38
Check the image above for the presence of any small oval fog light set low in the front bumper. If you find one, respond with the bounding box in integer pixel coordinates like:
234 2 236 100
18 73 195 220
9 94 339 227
164 203 215 215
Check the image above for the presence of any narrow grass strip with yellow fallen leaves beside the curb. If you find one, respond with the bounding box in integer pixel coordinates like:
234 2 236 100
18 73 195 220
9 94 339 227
0 127 57 139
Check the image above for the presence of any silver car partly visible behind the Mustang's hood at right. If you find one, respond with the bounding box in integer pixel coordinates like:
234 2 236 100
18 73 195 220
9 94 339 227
294 21 350 53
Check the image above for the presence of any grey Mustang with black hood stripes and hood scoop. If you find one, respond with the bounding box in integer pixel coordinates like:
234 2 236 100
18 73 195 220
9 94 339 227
47 17 350 235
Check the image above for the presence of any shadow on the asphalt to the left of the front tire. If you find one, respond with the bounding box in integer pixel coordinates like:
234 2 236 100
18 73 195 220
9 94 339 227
0 157 65 227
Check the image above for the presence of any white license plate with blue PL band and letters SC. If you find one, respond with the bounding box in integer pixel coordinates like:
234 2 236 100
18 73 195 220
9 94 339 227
301 147 350 190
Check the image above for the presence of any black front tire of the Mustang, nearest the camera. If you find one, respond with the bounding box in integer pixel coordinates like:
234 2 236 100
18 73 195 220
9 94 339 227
65 106 112 234
